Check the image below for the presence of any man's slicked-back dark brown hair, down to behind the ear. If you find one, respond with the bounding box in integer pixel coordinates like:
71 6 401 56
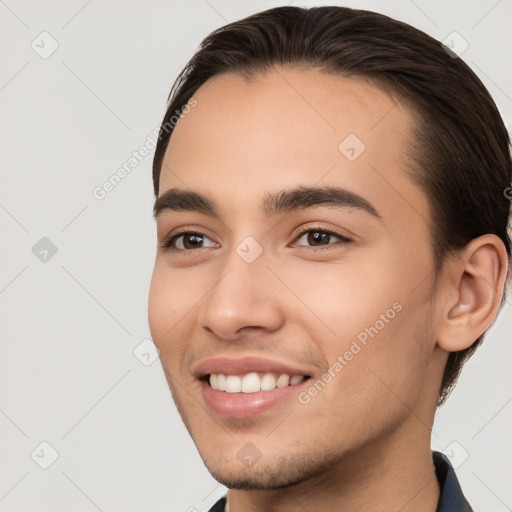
153 7 511 405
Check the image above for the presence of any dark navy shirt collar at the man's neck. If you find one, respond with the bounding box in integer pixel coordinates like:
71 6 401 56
210 452 473 512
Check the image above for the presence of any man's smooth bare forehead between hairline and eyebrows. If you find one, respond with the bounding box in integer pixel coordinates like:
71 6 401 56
160 68 428 228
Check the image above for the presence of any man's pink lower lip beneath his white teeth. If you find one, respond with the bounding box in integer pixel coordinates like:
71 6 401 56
201 379 308 418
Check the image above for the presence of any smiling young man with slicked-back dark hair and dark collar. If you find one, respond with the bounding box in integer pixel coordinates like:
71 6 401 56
149 7 511 512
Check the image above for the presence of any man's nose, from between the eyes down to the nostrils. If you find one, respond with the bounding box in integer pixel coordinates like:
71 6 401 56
199 247 286 340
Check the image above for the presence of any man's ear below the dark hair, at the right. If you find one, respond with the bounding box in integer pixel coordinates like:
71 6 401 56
437 234 509 352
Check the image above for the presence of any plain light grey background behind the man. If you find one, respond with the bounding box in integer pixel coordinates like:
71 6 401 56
0 0 512 512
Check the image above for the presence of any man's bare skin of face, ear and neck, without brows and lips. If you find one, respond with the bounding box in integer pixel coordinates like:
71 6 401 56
149 68 507 512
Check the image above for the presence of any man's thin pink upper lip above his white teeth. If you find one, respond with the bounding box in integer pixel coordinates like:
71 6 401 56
193 357 310 379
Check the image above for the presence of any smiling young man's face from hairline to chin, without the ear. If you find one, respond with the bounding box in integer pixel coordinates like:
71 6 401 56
149 69 446 488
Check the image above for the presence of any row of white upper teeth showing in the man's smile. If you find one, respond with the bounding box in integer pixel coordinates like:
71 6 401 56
209 372 304 393
